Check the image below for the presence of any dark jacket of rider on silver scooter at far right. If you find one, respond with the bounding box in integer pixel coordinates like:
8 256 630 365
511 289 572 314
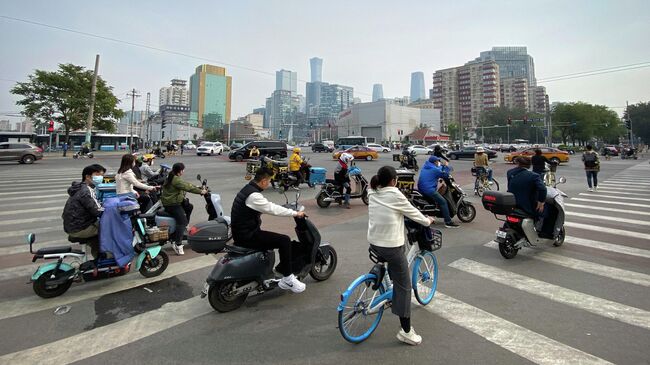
507 167 546 216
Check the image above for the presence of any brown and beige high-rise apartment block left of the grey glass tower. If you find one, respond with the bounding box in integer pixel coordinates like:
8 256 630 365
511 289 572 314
431 61 501 131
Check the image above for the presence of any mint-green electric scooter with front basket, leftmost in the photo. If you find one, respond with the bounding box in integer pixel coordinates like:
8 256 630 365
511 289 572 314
27 196 169 298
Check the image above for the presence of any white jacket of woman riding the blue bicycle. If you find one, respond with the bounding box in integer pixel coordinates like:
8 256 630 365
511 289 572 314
367 186 429 247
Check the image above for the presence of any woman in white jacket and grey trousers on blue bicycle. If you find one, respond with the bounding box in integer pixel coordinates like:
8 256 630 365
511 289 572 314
368 166 433 345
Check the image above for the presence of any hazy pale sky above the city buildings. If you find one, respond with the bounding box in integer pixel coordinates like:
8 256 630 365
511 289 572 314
0 1 650 118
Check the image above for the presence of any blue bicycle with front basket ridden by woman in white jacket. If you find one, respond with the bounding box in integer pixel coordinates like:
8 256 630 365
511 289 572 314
337 220 442 343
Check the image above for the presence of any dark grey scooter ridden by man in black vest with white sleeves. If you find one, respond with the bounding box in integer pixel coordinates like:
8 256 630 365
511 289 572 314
188 190 338 312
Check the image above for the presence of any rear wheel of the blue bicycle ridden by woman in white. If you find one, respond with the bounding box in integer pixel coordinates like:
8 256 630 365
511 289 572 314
339 276 385 343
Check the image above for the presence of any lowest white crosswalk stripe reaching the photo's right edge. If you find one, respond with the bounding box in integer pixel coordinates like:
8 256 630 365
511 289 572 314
449 258 650 329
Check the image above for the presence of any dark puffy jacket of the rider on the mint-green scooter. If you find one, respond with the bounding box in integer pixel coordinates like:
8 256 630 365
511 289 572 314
61 182 104 234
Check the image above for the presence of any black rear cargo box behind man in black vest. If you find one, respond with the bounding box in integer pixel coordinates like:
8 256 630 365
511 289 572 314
187 217 231 253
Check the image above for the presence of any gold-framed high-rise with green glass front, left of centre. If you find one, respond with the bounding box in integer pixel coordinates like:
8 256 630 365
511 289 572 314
190 65 232 129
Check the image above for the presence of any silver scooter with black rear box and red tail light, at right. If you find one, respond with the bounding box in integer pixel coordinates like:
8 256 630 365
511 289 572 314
482 176 567 259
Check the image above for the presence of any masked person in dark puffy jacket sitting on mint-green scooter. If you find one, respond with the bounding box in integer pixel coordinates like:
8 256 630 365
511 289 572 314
61 164 106 258
